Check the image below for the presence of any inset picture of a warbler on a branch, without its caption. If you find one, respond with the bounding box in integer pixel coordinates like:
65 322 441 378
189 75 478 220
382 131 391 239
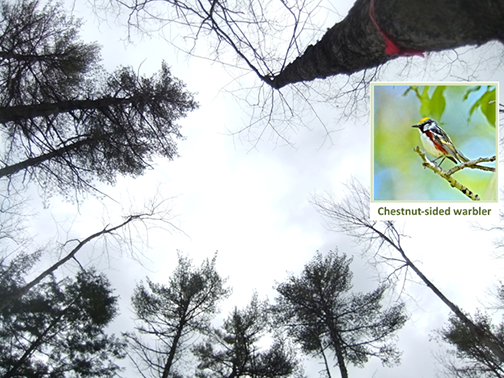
371 83 499 203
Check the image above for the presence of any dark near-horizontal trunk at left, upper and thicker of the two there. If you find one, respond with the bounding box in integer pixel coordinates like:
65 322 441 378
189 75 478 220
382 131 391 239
0 96 135 123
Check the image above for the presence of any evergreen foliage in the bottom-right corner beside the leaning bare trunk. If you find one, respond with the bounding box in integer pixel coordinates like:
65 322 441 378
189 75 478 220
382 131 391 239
437 312 504 378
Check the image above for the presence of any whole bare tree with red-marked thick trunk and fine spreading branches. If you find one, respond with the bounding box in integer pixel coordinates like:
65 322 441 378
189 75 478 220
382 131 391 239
90 0 503 144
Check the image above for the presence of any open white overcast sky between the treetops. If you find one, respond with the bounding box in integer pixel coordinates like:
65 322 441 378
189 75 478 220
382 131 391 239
17 1 503 378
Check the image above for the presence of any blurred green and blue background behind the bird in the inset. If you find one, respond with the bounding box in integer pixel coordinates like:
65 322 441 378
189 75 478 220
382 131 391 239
372 83 497 201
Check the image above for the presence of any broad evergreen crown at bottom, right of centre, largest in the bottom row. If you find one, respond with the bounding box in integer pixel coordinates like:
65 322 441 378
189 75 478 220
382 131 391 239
275 251 406 378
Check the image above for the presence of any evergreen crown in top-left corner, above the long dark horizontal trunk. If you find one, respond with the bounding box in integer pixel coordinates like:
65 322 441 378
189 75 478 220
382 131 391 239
0 0 100 107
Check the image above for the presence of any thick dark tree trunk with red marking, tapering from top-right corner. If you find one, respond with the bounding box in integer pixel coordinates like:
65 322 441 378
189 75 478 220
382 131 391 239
265 0 504 89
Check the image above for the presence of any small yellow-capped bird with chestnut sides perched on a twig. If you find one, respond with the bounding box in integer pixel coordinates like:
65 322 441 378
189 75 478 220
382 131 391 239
411 118 469 165
